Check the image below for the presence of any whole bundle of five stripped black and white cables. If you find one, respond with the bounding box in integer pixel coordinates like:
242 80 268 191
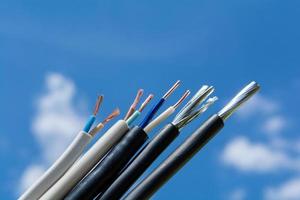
19 81 259 200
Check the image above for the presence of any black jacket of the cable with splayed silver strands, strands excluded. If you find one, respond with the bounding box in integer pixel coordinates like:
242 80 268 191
97 123 179 200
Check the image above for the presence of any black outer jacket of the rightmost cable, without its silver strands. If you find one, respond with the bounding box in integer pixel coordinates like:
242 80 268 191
124 115 224 200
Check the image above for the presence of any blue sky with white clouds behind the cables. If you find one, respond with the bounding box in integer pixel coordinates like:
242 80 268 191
0 0 300 200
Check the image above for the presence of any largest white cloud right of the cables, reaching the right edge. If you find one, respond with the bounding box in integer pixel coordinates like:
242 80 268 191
222 137 300 172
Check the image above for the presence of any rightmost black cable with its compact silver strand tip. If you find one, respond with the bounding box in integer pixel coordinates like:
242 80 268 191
124 82 259 200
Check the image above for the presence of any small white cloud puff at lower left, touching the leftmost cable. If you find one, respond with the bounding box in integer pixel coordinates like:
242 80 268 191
19 164 45 192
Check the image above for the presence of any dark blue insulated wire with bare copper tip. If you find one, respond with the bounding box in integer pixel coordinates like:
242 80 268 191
139 80 180 128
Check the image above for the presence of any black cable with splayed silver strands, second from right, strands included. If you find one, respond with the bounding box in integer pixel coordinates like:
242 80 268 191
97 87 213 200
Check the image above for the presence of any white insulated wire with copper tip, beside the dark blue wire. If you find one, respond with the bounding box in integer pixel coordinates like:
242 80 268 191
144 90 190 133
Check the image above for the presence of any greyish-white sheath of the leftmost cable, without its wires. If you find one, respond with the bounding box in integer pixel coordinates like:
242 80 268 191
19 131 92 200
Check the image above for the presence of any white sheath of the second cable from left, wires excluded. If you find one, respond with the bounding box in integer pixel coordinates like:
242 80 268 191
40 120 129 200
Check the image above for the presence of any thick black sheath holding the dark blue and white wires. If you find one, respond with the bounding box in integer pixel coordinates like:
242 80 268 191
65 126 148 200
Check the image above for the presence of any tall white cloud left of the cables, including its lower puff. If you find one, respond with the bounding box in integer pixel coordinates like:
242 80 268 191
19 73 85 194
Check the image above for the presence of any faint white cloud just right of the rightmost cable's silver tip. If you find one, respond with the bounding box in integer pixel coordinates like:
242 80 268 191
237 94 279 117
